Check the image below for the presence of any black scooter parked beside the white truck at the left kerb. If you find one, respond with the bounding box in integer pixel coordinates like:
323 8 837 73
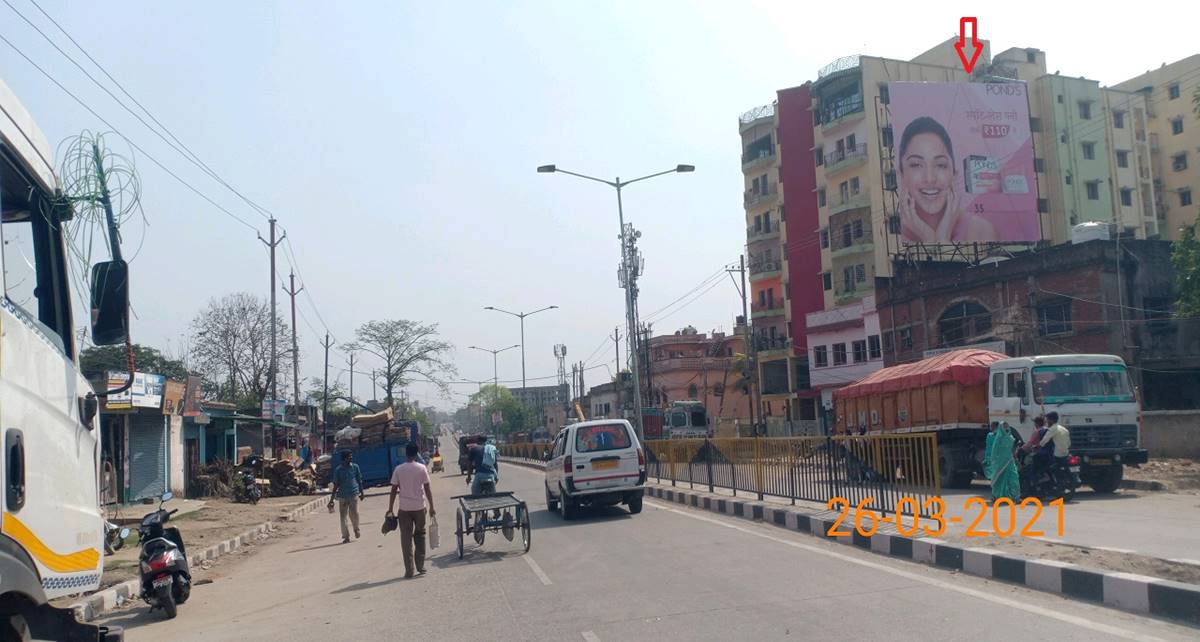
138 491 192 618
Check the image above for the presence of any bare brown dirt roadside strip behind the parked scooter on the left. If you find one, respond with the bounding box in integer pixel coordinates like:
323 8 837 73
93 496 316 588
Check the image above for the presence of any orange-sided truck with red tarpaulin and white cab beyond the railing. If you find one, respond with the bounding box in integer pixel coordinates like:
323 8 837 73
833 349 1147 493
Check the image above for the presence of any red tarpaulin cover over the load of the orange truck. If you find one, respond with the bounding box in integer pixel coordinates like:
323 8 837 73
833 348 1008 398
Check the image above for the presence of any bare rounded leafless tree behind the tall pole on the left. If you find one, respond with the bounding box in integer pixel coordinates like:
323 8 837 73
191 292 292 404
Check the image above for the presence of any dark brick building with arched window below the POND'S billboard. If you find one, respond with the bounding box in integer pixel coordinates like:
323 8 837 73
876 239 1200 409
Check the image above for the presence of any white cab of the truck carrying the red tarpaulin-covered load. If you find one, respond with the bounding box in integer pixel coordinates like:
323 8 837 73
988 354 1147 493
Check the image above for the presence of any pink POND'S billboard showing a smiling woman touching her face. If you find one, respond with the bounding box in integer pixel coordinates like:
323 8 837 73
888 83 1042 245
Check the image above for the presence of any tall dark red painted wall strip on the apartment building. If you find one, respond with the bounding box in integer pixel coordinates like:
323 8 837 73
776 84 824 355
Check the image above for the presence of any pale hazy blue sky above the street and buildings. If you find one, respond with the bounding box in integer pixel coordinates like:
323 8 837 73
0 0 1200 409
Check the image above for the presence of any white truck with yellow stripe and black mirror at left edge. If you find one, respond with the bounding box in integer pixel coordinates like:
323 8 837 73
0 82 128 640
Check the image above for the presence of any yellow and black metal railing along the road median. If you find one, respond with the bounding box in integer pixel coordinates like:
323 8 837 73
499 434 942 516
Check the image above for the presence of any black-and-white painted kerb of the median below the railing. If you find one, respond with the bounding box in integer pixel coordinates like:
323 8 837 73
504 457 1200 625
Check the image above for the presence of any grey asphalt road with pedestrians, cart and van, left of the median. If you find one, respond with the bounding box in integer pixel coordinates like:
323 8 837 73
109 444 1196 642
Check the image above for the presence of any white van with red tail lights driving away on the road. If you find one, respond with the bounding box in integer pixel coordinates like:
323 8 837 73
546 419 646 520
